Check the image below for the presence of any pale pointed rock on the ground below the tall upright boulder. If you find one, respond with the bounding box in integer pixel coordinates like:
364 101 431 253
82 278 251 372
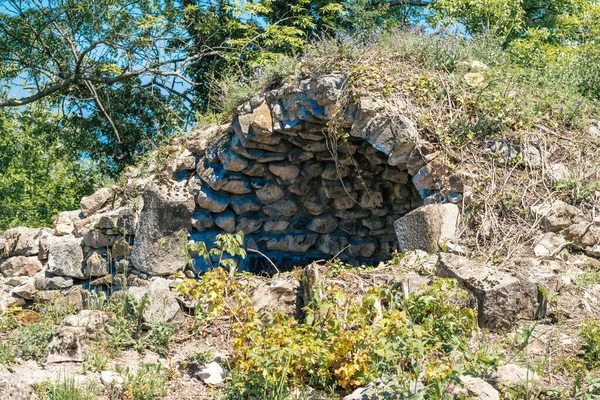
128 278 179 323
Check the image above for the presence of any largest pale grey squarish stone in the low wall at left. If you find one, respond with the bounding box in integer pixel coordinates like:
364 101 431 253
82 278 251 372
48 236 84 279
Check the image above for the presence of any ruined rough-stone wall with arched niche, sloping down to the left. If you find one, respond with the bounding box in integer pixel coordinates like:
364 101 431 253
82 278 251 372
0 75 463 305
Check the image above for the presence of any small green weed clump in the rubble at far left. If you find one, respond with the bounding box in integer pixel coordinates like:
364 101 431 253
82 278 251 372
14 321 53 361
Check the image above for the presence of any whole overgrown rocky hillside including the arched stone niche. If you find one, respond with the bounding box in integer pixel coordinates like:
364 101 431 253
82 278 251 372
0 32 600 400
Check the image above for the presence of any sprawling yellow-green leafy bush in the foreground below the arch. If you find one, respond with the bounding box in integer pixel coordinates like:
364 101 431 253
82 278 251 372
228 281 494 399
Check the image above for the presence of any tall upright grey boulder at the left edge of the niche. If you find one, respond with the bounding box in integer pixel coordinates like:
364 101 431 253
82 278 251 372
131 181 195 275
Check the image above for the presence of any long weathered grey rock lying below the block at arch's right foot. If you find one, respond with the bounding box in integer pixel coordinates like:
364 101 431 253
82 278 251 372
437 253 541 329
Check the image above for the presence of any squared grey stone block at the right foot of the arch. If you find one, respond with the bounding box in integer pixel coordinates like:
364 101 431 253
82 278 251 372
394 204 458 253
